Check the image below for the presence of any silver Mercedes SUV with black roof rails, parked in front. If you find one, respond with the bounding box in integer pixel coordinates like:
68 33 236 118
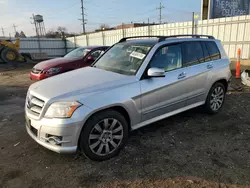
25 35 231 160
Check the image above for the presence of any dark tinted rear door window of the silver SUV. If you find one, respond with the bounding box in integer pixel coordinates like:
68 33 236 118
183 42 204 66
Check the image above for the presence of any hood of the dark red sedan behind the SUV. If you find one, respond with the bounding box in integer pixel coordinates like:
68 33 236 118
34 57 75 70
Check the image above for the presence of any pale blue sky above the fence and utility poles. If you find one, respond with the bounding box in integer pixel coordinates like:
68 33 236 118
0 0 201 36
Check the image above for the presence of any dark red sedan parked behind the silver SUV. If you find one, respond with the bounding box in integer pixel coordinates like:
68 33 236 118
30 46 108 80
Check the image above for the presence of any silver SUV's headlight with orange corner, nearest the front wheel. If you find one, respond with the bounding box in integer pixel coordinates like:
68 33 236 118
45 101 82 118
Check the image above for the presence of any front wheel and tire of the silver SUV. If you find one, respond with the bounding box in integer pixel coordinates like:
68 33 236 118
79 110 128 161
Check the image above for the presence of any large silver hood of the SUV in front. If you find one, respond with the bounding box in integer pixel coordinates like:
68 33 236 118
29 67 137 100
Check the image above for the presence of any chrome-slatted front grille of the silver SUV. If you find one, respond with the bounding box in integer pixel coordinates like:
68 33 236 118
26 95 44 117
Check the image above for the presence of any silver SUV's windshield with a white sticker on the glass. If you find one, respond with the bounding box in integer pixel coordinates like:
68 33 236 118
94 43 153 75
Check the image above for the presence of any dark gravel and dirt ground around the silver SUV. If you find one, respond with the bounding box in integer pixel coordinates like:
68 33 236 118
0 65 250 188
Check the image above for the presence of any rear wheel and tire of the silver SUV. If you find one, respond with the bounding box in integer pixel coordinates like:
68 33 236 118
204 82 226 114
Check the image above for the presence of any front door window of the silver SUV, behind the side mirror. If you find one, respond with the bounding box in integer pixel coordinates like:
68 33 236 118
150 44 182 71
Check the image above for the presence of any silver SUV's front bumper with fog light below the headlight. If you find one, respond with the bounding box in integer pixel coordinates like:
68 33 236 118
26 106 93 153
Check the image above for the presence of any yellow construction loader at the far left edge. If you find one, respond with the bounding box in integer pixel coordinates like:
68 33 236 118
0 39 31 63
